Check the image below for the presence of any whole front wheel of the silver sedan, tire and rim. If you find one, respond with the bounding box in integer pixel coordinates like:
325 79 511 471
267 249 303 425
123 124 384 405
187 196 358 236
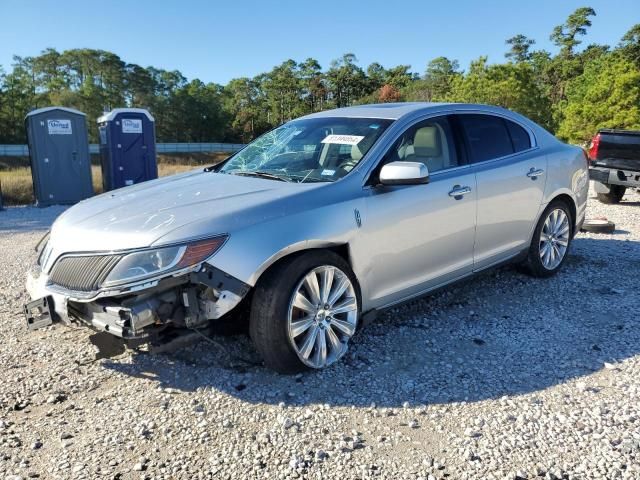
249 250 361 373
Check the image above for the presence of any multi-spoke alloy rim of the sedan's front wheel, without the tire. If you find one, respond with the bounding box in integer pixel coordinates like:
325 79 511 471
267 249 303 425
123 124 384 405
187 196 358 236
288 265 358 368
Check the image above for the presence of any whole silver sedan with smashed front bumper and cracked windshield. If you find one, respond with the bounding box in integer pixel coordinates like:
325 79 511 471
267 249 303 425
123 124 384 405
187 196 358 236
25 103 588 372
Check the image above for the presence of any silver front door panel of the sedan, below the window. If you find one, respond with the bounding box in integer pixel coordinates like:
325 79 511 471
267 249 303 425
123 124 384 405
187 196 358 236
362 168 476 308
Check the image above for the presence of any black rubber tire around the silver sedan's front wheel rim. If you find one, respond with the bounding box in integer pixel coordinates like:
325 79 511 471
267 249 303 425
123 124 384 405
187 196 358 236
249 250 361 374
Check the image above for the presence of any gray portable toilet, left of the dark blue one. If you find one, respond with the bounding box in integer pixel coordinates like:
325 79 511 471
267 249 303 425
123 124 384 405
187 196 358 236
25 107 93 207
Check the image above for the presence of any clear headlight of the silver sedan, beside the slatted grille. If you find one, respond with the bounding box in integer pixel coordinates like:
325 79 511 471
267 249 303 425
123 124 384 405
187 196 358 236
103 236 227 286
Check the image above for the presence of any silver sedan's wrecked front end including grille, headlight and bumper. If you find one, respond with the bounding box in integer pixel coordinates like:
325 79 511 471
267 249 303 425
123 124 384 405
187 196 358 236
25 236 250 343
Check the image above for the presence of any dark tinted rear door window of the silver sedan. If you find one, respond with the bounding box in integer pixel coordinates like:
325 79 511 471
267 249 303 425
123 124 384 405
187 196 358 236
458 114 514 163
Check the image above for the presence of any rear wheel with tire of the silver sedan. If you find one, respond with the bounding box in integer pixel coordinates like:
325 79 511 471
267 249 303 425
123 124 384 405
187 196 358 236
524 201 573 277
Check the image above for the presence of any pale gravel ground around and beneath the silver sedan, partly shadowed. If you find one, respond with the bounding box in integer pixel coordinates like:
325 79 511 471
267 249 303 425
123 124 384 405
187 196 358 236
0 188 640 480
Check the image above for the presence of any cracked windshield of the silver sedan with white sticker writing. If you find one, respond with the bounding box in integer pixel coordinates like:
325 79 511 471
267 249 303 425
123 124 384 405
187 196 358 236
219 118 391 183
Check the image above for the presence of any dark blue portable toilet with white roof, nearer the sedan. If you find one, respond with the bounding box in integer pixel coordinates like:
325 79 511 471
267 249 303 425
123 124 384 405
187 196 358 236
98 108 158 192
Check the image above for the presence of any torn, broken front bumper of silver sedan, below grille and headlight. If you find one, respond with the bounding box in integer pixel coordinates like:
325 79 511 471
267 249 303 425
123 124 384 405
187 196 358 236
25 263 250 342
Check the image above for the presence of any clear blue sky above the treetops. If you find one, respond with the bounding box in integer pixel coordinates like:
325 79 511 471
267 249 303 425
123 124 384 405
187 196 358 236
0 0 640 84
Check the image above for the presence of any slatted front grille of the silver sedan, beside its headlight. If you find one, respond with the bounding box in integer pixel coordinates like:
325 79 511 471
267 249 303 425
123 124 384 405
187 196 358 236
49 255 123 292
